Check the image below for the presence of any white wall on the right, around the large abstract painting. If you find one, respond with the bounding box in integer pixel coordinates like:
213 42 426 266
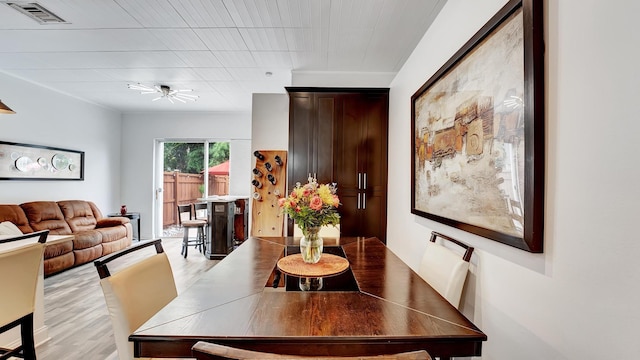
387 0 640 360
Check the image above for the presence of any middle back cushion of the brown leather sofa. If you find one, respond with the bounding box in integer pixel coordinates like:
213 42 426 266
20 201 72 235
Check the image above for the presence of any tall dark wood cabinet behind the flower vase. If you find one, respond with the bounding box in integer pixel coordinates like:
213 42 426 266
287 88 389 241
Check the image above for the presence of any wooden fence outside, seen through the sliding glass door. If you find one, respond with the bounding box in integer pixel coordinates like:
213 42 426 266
162 171 229 228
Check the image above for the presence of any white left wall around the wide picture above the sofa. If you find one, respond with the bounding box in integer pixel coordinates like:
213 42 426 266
0 72 121 215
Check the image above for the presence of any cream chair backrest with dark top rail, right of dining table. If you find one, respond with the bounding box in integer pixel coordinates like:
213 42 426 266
418 231 473 308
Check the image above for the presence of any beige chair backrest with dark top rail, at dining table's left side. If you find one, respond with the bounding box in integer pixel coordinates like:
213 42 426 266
94 239 178 360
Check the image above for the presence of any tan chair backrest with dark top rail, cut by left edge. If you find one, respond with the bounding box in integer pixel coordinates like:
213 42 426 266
0 230 49 326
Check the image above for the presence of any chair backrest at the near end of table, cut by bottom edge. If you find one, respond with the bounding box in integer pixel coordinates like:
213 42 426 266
191 341 431 360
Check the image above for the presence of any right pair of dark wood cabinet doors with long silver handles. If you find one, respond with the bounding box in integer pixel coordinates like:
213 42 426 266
334 94 388 241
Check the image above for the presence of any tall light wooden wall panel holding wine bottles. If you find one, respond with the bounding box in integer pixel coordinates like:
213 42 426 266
251 150 287 236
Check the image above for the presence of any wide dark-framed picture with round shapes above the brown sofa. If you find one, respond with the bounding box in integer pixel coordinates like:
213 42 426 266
0 141 84 180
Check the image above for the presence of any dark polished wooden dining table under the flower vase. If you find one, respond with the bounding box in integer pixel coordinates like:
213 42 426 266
129 237 487 359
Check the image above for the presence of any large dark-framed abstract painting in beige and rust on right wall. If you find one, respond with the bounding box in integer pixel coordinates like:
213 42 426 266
411 0 545 253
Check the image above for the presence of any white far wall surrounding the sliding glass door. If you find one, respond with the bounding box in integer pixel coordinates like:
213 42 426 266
121 112 252 239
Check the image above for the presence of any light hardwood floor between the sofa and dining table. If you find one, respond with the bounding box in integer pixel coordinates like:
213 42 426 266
36 238 219 360
